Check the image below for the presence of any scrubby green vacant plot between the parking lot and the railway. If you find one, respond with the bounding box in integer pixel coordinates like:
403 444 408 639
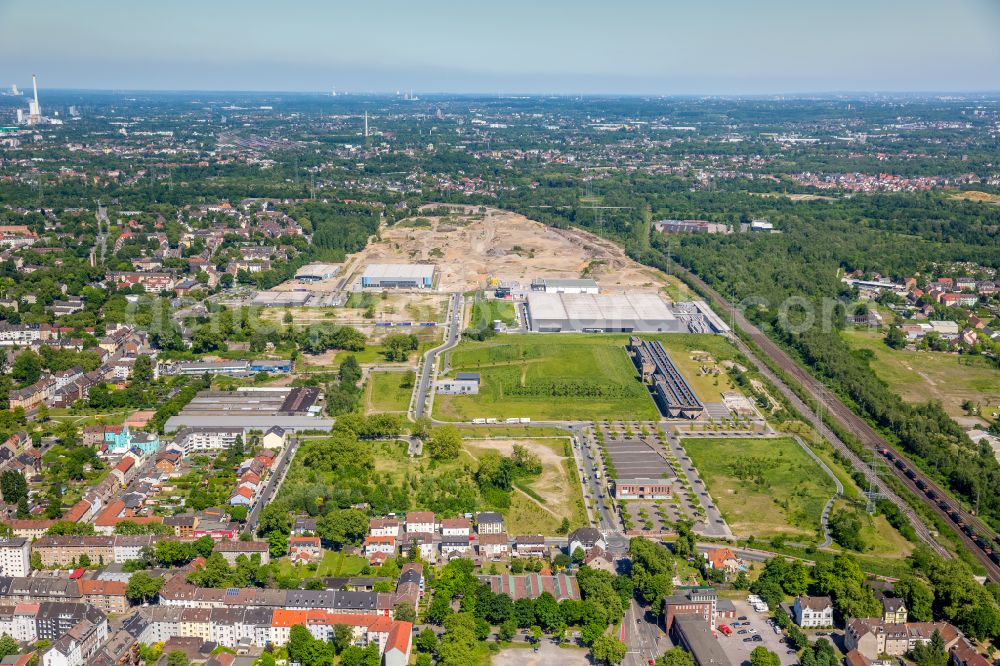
683 438 836 540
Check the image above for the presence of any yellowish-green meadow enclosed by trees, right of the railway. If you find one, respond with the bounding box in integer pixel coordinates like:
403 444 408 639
841 331 1000 416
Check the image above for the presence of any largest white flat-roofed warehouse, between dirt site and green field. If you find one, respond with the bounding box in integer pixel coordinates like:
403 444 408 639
527 291 687 333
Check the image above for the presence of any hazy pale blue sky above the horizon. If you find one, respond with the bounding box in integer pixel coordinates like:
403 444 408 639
0 0 1000 94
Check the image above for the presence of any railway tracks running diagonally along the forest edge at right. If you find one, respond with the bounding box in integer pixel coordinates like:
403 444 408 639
678 267 1000 581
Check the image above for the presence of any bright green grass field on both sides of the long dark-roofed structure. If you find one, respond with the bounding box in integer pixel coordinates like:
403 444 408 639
434 333 737 421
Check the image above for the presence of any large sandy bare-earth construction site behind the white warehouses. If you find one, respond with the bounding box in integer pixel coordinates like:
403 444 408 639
345 204 680 293
